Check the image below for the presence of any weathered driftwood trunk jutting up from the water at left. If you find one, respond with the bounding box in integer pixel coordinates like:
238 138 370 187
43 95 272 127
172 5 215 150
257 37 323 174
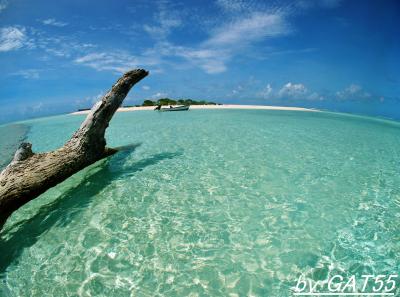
0 69 148 230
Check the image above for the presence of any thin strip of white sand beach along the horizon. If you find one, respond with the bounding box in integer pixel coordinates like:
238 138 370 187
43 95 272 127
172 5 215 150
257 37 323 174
70 104 319 115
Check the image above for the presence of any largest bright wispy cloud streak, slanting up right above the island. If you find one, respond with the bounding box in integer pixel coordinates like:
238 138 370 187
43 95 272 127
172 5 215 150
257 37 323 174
144 12 290 74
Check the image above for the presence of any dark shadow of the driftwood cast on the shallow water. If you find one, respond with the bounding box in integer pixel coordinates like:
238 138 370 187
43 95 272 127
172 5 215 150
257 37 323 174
0 145 182 277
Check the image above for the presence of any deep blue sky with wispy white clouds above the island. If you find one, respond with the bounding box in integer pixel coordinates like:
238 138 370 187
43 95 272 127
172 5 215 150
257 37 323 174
0 0 400 123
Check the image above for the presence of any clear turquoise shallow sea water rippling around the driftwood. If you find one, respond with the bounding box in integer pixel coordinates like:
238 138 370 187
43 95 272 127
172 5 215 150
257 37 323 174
0 110 400 296
